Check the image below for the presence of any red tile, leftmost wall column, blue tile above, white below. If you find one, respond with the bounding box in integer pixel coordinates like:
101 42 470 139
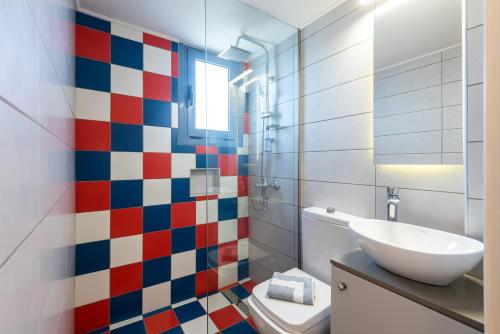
75 181 111 212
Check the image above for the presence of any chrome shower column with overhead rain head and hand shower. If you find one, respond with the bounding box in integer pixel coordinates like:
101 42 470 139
218 35 280 211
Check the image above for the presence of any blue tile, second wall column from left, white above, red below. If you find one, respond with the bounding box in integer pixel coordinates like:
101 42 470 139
111 180 142 209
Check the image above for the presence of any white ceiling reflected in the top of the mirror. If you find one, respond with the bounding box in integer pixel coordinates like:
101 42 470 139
374 0 462 69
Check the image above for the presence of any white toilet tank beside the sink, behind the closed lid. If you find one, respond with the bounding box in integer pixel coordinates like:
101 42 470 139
301 207 358 284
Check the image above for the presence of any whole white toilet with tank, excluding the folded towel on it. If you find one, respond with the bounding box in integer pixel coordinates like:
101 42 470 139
248 208 355 334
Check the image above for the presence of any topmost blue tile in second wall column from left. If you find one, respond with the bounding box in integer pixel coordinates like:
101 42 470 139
111 35 142 70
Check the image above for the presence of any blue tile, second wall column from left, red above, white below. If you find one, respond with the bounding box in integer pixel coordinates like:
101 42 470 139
111 123 142 152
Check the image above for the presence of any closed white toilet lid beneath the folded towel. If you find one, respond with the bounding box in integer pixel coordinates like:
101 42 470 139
252 268 331 333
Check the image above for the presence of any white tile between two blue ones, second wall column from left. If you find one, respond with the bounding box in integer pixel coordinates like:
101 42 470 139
111 152 143 180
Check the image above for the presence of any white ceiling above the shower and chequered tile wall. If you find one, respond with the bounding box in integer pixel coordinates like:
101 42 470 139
78 0 339 54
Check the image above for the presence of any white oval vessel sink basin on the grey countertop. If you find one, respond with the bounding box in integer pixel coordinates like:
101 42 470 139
349 219 484 285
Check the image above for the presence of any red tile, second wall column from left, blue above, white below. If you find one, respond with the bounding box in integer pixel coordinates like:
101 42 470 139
111 207 142 238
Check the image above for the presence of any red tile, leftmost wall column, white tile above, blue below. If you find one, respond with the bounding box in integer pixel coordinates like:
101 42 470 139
75 119 111 151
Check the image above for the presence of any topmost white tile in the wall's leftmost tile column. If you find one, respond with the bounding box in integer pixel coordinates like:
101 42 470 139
76 88 111 122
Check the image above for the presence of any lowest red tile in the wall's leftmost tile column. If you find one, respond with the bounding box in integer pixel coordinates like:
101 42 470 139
75 299 109 334
